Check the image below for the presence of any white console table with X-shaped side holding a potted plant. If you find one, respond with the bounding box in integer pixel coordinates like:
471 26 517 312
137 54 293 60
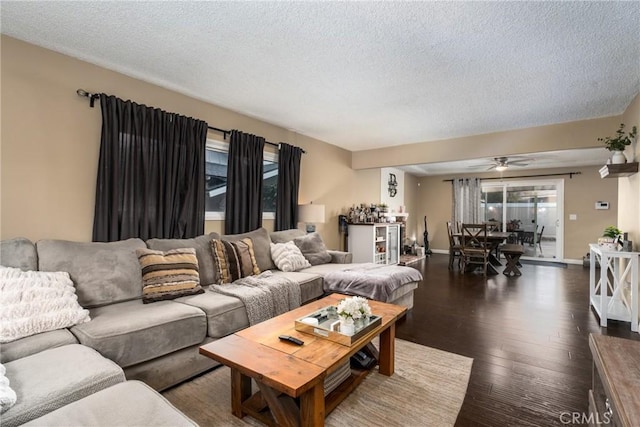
589 243 640 332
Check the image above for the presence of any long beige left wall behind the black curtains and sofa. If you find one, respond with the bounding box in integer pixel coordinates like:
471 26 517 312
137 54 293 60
0 36 352 248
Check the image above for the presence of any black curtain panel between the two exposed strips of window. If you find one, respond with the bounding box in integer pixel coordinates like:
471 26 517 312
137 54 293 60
224 130 265 234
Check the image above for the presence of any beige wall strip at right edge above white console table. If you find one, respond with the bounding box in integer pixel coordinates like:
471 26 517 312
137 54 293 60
618 94 640 251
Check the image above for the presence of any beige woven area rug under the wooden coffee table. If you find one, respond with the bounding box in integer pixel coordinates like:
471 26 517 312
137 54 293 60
162 340 473 427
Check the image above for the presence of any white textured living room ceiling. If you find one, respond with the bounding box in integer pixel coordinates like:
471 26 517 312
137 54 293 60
0 1 640 155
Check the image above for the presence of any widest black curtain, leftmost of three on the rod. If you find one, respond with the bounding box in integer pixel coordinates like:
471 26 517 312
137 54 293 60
93 94 207 242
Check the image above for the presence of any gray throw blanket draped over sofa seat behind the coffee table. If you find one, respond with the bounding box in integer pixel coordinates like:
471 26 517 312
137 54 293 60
209 270 301 325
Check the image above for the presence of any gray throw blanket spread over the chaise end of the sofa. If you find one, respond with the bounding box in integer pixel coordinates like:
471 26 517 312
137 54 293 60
324 263 422 302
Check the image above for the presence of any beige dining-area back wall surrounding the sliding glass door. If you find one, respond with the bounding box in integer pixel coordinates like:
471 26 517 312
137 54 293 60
418 166 618 260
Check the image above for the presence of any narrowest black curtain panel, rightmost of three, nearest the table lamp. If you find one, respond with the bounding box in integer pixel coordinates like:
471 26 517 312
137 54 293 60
275 142 303 231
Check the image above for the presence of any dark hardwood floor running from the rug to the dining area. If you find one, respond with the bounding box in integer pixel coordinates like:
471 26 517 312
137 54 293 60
396 254 640 426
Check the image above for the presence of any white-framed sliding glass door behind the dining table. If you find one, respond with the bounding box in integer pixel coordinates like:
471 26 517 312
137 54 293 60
481 179 564 261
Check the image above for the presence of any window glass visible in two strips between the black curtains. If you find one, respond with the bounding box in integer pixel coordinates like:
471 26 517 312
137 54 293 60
205 140 278 220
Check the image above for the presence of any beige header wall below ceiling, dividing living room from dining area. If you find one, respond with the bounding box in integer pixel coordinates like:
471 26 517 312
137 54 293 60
352 116 620 169
